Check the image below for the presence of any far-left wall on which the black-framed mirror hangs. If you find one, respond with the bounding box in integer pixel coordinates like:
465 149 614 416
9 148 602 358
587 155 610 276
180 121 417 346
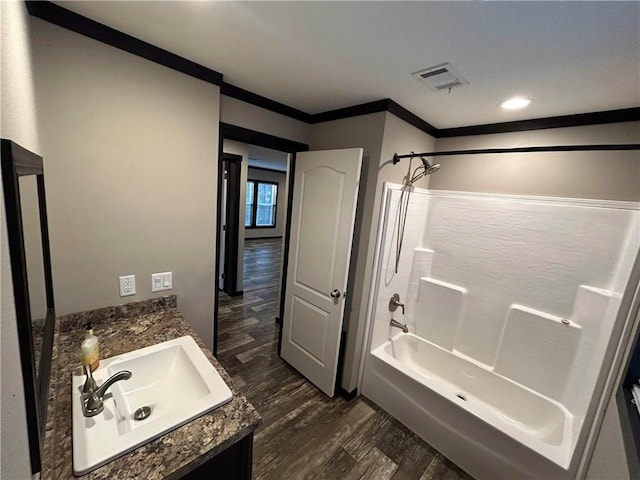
0 2 40 479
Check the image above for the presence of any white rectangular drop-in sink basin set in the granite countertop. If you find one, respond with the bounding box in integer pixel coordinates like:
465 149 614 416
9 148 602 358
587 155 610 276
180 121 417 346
72 336 232 475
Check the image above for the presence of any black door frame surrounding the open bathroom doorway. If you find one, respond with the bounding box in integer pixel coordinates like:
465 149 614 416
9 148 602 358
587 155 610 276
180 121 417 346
213 122 309 357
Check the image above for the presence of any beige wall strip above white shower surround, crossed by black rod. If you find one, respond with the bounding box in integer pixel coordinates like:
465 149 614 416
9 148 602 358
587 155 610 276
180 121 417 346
431 122 640 201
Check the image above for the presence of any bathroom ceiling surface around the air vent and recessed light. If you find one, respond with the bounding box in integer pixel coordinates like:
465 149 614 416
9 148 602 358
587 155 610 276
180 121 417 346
55 1 640 128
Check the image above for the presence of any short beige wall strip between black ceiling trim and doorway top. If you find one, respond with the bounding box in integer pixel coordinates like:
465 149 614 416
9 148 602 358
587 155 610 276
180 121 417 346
220 95 311 144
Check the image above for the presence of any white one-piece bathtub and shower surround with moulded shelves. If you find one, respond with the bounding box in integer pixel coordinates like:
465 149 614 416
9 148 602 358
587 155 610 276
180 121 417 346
361 184 640 478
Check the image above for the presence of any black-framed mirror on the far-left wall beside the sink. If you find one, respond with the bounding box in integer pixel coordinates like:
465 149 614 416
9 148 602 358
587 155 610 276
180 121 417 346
1 139 55 474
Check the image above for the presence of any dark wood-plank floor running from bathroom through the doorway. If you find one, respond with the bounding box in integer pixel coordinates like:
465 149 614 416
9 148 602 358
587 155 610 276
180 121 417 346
218 239 472 480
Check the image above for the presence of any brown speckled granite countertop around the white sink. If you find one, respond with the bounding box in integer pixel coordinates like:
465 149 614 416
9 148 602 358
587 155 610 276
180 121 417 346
41 295 260 480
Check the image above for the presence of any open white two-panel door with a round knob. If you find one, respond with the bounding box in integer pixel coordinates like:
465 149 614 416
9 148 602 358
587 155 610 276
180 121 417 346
280 148 362 397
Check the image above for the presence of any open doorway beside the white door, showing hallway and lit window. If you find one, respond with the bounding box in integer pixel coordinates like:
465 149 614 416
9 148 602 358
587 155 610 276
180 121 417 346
217 144 289 359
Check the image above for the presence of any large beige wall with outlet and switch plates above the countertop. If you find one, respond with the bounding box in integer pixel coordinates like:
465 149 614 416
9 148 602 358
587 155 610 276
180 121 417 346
32 19 219 348
